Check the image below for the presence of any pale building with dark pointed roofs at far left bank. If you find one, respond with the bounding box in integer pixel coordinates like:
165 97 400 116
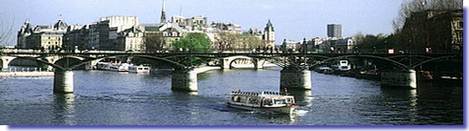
17 19 68 50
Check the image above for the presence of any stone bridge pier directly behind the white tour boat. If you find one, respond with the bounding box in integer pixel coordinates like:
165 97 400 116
280 67 311 90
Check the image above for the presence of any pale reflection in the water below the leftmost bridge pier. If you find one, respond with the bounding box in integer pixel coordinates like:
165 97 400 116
54 94 77 125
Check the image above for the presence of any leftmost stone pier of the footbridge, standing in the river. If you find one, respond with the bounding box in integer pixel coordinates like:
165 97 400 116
54 69 73 94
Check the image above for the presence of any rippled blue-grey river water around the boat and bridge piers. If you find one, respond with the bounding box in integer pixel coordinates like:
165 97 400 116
0 68 463 126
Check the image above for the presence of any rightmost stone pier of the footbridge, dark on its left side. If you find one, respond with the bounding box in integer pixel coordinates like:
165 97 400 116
381 70 417 88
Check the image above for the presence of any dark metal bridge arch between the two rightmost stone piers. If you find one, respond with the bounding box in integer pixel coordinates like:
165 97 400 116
311 55 412 71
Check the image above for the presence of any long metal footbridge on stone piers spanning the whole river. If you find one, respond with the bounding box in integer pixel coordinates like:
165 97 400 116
0 49 462 93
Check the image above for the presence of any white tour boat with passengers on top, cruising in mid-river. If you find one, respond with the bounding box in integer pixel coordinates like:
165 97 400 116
227 91 296 115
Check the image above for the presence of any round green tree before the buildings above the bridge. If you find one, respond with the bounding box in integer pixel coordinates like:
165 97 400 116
172 33 212 52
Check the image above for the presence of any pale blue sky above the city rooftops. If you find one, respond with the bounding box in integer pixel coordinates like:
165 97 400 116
0 0 405 45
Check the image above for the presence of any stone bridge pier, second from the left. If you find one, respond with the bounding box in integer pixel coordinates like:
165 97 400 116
171 70 197 92
